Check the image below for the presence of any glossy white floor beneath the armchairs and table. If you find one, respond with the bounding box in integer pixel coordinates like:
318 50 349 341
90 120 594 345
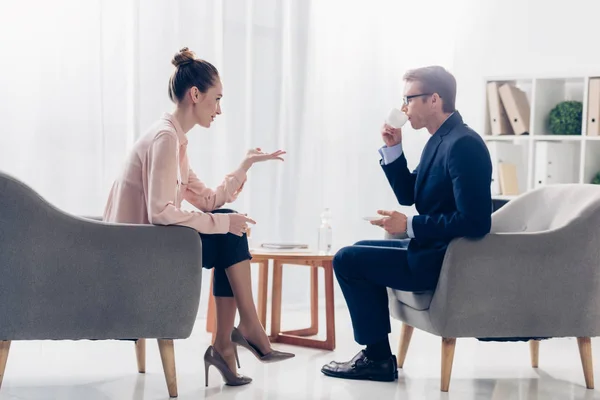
0 308 600 400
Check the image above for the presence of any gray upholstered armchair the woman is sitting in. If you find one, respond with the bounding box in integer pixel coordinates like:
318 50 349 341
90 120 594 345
0 173 202 397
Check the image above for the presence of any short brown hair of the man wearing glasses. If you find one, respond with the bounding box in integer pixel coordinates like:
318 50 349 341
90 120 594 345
403 65 456 113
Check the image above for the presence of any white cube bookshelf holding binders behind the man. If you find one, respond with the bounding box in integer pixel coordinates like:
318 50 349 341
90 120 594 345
482 74 600 199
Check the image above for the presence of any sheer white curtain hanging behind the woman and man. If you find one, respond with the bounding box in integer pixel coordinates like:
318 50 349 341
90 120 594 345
0 0 458 310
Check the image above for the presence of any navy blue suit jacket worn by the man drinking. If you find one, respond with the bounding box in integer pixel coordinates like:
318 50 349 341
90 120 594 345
382 111 492 289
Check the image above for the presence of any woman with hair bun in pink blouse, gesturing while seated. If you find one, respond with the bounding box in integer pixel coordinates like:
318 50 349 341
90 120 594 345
104 48 294 385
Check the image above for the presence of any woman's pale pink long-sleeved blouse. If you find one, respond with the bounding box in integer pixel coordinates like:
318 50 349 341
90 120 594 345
104 114 247 233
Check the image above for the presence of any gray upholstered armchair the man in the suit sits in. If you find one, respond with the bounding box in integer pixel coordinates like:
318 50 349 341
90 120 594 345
388 184 600 391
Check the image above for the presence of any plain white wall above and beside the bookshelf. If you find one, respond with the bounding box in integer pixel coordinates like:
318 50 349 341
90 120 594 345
453 0 600 133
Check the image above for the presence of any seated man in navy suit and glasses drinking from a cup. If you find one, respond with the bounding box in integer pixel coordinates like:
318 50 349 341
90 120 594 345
321 66 492 381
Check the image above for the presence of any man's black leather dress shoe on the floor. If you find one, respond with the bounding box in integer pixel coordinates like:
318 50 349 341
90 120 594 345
321 350 398 382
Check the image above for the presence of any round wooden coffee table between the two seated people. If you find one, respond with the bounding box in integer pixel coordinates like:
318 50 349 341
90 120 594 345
206 249 335 350
